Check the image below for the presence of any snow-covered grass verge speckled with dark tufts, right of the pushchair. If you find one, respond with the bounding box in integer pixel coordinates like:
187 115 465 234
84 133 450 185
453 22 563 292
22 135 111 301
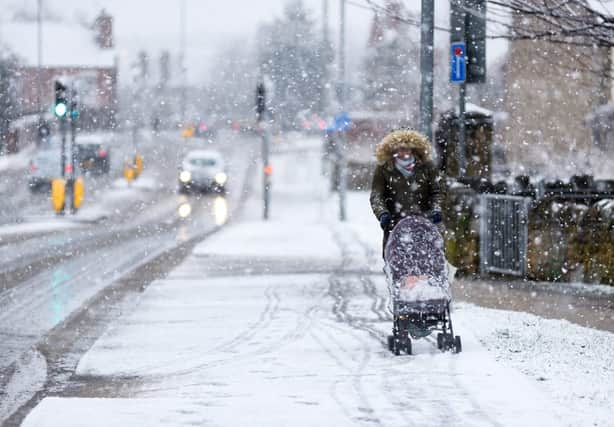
454 303 614 426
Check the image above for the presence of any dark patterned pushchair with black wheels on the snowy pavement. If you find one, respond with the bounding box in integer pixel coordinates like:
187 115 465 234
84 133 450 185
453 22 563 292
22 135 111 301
384 215 461 355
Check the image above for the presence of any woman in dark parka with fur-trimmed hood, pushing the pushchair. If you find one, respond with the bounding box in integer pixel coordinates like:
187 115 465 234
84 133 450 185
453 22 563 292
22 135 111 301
371 129 442 258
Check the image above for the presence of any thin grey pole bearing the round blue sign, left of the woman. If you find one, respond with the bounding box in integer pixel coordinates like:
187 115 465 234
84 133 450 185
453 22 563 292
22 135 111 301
335 0 347 221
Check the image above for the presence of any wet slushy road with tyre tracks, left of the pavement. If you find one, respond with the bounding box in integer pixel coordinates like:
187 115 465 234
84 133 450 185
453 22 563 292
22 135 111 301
0 129 260 423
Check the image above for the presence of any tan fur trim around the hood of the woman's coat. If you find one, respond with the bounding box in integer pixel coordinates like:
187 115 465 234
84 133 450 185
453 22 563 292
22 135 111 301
375 129 431 168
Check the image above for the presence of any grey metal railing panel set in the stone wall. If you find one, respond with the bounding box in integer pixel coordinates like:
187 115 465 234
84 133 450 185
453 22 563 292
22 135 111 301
480 194 531 276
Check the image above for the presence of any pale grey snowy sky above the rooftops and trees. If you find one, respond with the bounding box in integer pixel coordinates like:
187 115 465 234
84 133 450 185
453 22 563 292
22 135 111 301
0 0 503 82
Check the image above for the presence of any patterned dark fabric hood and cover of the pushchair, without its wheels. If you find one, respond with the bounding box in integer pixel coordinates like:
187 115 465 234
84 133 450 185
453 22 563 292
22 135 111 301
384 216 452 304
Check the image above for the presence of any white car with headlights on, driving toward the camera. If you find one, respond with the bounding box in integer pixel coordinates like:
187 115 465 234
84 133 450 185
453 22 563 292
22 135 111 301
177 150 228 194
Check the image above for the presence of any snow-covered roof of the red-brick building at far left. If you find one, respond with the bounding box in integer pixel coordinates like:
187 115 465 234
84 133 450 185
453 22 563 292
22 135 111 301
0 21 116 68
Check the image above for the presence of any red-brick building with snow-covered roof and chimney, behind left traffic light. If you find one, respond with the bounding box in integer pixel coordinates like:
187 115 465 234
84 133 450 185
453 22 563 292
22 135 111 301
0 11 118 128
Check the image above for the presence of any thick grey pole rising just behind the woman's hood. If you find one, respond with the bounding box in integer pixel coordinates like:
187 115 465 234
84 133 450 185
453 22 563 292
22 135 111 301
420 0 435 144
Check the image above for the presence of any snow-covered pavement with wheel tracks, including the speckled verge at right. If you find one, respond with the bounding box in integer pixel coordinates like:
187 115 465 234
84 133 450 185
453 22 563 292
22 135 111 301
23 141 614 426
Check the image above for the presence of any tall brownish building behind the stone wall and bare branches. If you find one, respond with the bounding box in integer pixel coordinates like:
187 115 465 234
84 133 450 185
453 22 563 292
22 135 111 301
501 18 611 178
